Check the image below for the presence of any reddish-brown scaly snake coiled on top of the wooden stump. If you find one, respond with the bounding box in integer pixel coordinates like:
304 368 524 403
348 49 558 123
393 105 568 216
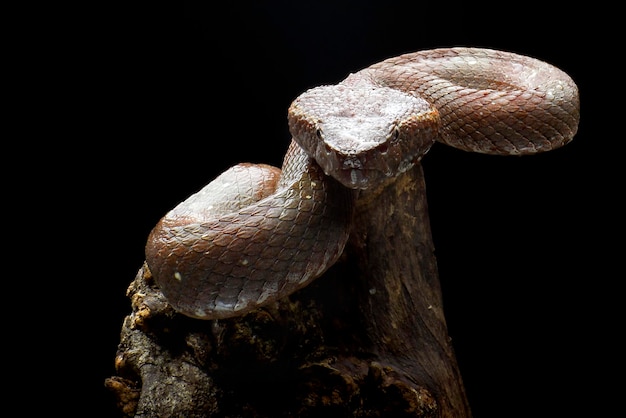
145 47 580 320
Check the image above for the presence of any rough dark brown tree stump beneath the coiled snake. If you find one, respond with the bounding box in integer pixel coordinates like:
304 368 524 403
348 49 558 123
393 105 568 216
105 164 471 418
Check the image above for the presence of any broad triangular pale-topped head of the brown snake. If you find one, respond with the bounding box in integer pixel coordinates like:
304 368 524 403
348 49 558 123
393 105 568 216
288 76 439 189
